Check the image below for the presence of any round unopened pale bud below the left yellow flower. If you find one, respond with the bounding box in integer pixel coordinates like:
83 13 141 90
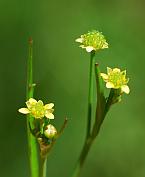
44 124 57 139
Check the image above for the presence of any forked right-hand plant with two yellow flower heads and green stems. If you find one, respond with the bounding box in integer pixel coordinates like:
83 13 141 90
73 30 130 177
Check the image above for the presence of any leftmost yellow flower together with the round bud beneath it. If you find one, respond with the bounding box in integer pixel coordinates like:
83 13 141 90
18 98 57 141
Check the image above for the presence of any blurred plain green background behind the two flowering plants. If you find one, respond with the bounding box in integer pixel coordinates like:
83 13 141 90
0 0 145 177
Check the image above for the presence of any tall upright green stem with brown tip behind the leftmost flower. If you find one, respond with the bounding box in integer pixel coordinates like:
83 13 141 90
26 39 39 177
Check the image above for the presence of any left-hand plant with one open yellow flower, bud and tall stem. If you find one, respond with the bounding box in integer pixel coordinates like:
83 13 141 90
18 38 67 177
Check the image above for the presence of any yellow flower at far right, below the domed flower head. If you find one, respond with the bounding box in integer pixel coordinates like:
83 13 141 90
101 67 130 94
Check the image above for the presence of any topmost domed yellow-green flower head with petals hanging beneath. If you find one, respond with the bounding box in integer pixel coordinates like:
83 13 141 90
76 30 108 52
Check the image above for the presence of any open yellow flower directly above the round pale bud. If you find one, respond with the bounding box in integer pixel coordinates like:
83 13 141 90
18 98 54 119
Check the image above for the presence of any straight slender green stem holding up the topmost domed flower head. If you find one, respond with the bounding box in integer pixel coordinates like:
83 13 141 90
86 52 95 139
